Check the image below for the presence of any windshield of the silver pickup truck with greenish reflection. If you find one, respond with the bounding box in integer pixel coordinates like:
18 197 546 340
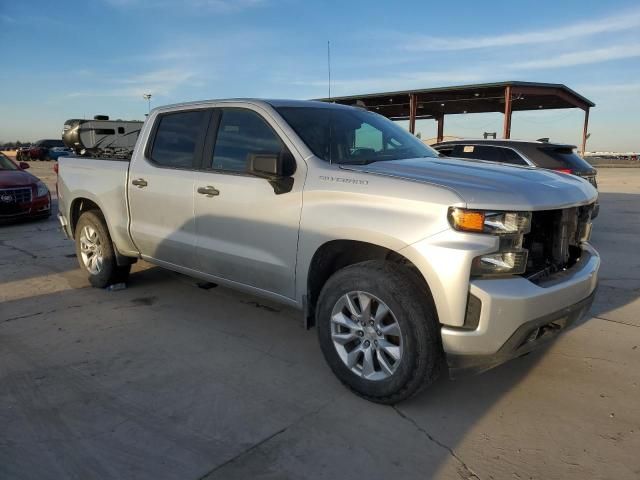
276 107 438 164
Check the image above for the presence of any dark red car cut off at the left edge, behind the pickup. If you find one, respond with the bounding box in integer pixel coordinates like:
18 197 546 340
0 153 51 221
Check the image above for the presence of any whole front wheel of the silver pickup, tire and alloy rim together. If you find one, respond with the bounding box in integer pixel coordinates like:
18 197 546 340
316 261 444 404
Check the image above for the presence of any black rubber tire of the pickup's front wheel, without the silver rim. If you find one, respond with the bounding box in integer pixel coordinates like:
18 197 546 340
316 261 444 404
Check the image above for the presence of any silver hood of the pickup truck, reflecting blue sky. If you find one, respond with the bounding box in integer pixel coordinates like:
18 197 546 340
342 158 598 211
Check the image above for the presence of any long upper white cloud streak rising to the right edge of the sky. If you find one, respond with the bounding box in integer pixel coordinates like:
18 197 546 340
404 11 640 51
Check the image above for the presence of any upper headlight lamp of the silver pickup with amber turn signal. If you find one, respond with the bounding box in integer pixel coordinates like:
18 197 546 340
448 207 531 235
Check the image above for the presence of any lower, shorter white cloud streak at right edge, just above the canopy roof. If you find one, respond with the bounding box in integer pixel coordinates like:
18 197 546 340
511 44 640 70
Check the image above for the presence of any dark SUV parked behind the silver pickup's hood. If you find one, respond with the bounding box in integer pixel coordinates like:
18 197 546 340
433 140 598 188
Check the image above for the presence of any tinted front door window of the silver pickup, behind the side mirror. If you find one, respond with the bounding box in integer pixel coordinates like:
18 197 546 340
211 108 285 172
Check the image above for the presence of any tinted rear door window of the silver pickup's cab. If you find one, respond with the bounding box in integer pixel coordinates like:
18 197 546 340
150 110 209 168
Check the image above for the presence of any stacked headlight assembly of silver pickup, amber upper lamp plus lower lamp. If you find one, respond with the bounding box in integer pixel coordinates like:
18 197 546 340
448 208 531 276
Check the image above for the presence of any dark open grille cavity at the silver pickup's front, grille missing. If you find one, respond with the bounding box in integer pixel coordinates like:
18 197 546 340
523 204 593 282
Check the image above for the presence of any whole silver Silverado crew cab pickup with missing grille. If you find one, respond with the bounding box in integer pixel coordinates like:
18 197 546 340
58 100 600 403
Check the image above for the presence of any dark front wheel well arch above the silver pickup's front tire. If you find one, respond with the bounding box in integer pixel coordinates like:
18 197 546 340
305 240 431 328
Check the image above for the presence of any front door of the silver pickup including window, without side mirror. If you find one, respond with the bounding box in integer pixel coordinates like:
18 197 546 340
194 107 306 298
